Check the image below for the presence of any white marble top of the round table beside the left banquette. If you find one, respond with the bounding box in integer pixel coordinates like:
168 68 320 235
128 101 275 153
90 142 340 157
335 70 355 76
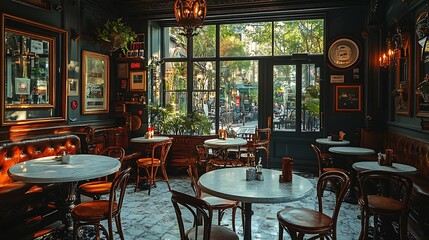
8 154 121 183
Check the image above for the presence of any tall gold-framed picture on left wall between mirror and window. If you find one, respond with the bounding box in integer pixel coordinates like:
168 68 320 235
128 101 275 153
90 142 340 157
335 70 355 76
82 51 110 114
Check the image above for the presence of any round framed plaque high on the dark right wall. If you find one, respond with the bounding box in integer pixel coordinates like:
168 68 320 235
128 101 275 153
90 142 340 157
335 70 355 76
328 38 359 69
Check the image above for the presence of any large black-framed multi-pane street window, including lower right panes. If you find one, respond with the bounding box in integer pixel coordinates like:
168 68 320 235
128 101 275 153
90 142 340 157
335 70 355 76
160 19 324 133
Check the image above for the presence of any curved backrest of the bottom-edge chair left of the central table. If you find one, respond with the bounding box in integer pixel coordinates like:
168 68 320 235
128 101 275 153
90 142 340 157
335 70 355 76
171 190 213 240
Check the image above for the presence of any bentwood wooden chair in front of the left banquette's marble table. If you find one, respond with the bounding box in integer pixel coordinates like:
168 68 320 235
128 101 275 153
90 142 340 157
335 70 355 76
71 168 131 240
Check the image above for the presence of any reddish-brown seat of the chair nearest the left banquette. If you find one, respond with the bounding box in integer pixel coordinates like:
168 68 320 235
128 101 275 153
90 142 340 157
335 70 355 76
71 200 118 222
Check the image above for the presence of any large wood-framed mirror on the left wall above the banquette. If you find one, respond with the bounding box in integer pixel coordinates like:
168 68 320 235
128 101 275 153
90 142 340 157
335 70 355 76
1 14 67 125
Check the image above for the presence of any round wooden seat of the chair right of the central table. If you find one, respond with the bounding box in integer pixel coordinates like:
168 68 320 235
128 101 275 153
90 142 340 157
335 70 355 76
277 208 332 232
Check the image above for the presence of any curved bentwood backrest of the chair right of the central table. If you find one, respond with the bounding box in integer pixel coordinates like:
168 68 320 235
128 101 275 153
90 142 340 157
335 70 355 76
317 171 350 229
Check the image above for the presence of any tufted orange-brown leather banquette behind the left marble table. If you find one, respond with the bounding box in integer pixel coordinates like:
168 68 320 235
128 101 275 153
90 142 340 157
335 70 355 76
0 135 81 239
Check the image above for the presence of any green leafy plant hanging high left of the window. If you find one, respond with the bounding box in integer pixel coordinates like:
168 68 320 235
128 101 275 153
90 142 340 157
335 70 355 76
96 18 137 54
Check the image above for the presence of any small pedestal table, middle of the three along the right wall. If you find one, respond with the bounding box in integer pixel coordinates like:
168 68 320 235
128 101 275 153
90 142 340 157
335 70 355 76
328 146 375 203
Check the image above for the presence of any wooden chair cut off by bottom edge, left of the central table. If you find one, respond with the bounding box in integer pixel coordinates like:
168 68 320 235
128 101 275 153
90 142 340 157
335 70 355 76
171 190 239 240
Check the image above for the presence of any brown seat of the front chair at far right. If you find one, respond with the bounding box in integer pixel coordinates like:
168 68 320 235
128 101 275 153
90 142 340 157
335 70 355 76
358 195 402 215
